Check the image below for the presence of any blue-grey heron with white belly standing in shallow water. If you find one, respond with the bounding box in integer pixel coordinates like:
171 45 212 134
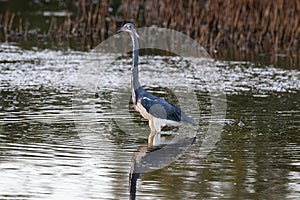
117 23 196 146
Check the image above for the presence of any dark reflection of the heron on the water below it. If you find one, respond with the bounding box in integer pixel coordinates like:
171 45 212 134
129 137 196 200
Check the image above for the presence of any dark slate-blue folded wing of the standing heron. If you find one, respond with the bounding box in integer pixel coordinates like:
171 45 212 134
140 95 195 124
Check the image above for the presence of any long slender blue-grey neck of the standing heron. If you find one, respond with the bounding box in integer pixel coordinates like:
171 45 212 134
131 32 141 104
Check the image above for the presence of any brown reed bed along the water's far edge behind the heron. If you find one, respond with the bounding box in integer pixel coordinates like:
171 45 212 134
0 0 300 52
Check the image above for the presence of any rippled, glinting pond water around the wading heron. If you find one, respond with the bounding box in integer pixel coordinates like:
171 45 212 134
0 44 300 199
